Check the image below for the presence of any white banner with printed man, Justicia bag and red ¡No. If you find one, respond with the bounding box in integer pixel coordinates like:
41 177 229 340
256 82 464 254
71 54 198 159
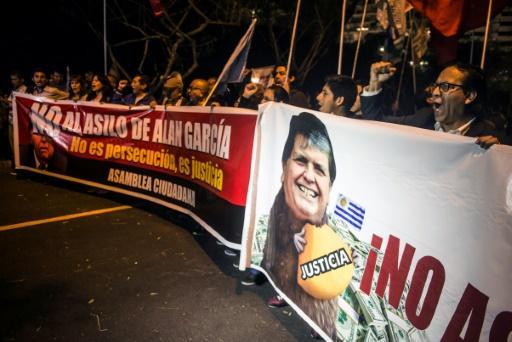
241 103 512 341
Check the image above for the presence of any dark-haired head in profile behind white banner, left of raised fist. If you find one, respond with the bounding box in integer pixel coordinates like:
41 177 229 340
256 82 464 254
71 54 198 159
316 75 357 116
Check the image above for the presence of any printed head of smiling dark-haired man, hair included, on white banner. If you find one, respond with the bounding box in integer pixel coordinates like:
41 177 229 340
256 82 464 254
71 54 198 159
281 112 336 224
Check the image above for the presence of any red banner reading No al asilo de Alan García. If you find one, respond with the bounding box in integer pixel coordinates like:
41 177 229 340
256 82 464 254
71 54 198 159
15 95 256 243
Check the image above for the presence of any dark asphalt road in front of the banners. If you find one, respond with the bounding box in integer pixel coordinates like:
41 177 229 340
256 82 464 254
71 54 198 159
0 162 312 341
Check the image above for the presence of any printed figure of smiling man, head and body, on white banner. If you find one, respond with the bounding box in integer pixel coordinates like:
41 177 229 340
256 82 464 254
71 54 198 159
261 112 338 340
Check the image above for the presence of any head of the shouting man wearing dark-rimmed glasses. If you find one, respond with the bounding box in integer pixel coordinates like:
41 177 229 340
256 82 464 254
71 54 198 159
432 63 486 127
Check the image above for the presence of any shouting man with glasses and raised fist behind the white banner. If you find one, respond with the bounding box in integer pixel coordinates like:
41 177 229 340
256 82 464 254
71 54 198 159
361 62 503 148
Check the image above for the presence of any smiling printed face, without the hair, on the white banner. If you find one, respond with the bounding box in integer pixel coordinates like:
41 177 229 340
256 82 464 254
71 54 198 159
282 134 330 224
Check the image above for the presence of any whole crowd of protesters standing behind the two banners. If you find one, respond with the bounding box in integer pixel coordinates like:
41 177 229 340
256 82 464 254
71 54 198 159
0 61 512 183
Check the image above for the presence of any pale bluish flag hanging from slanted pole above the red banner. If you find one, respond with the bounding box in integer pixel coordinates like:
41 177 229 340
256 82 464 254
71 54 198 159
220 19 256 84
